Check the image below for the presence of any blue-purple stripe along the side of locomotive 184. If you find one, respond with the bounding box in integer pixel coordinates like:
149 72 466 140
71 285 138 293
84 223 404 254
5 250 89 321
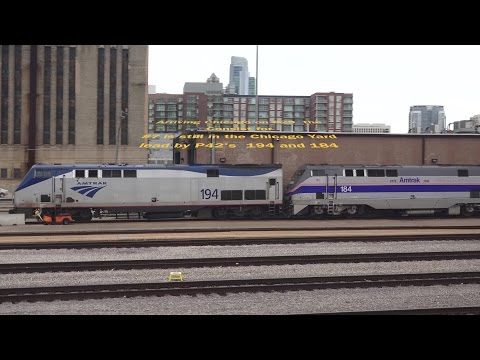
287 184 480 195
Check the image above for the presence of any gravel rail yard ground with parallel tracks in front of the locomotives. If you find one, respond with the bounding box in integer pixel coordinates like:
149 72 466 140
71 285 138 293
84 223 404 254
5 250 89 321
0 227 480 314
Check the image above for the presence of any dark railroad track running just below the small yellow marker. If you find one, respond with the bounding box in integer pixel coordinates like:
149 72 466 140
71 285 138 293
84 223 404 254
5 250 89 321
0 272 480 303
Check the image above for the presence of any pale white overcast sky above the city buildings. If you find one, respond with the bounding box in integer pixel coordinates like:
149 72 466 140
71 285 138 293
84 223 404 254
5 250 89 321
148 45 480 133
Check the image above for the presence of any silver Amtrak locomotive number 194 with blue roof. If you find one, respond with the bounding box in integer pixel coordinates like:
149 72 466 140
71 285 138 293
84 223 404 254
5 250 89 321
12 165 283 221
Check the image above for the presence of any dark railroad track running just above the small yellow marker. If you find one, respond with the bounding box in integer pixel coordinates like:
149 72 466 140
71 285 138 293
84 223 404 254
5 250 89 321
0 251 480 274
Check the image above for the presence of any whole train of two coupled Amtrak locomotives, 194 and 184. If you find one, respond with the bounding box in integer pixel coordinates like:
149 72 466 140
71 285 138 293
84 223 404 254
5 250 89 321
12 165 480 221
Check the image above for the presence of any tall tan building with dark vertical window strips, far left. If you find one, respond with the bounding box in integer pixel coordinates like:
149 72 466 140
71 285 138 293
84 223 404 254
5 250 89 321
0 45 148 191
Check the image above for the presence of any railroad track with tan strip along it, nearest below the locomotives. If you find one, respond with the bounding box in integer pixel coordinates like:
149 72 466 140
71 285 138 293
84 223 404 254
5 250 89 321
0 225 480 250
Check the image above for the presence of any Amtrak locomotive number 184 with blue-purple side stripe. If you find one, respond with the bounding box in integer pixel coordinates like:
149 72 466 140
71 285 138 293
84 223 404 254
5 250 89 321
286 165 480 216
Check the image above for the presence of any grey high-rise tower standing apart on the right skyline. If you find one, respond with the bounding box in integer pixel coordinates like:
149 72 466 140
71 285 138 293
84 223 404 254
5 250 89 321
408 105 446 134
